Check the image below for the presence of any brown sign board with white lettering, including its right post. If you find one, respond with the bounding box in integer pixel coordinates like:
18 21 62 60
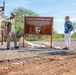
23 16 53 48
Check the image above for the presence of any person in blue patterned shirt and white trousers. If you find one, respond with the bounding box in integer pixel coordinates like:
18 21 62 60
63 16 74 50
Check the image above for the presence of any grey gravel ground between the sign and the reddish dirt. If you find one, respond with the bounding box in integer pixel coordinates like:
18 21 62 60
0 41 76 60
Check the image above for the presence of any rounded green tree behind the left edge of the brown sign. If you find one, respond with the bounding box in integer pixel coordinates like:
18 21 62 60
13 7 38 37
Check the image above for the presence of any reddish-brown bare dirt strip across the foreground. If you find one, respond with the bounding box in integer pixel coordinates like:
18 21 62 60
0 55 76 75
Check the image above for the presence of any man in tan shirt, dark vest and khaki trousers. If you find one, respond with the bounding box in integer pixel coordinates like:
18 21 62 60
5 13 19 49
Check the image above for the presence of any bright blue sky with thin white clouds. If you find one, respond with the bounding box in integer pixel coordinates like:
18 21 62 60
0 0 76 33
